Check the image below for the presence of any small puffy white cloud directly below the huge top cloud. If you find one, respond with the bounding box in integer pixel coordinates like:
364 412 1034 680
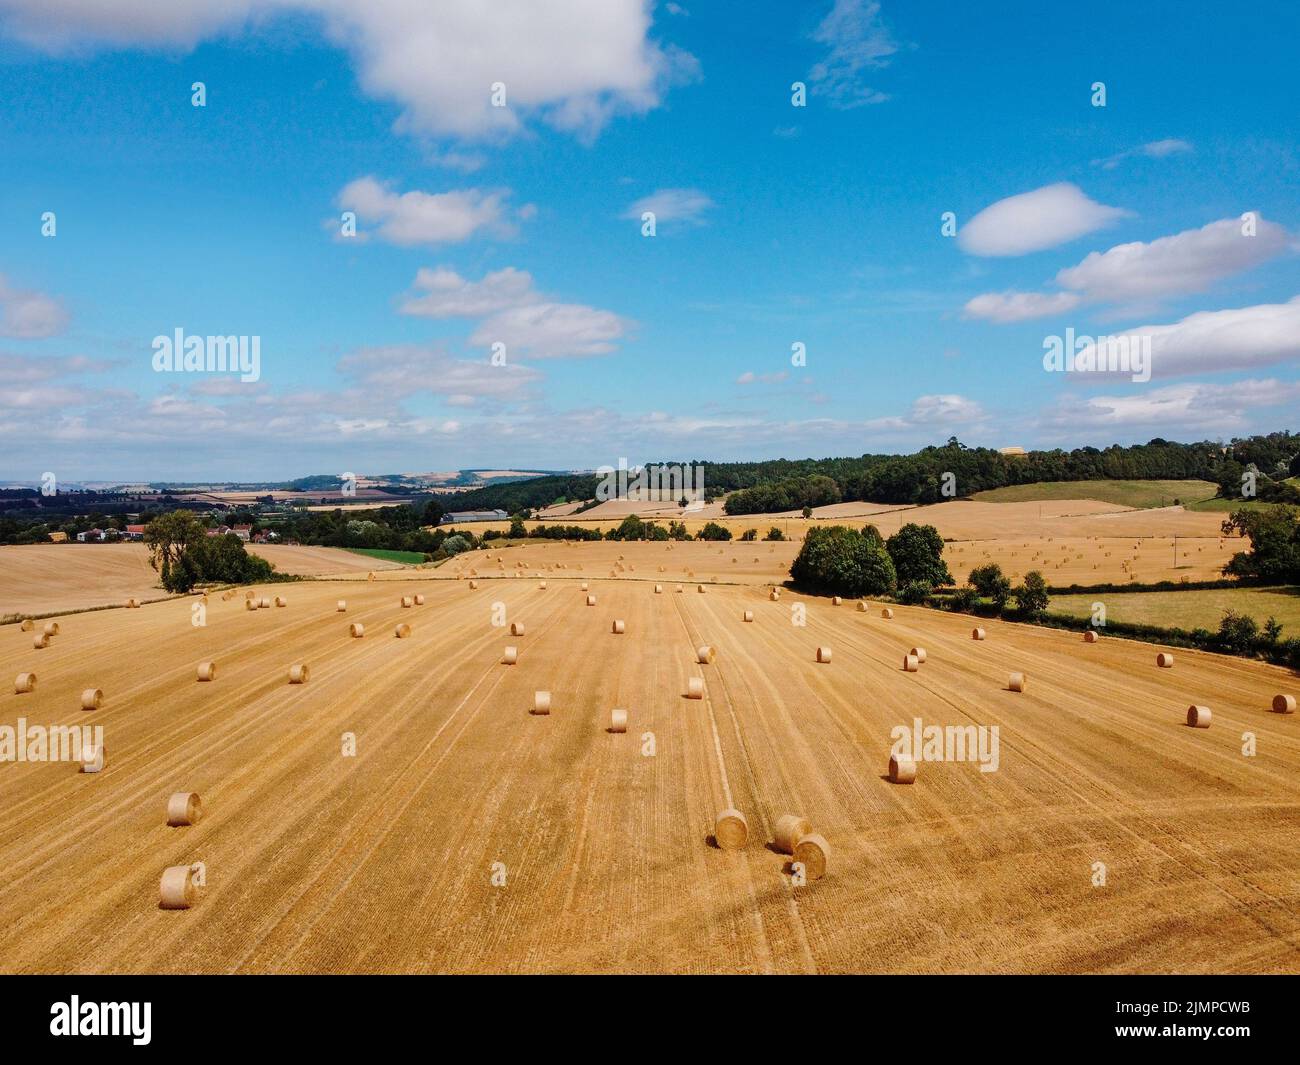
338 176 514 247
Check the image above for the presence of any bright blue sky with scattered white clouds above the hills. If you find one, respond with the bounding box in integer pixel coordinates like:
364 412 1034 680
0 0 1300 481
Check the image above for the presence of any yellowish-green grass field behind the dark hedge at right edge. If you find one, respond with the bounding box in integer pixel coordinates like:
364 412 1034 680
1048 588 1300 636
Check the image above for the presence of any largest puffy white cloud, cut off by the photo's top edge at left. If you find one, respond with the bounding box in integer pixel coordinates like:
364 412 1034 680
0 0 698 139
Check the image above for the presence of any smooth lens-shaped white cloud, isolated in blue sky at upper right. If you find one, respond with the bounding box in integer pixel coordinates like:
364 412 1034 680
957 182 1130 256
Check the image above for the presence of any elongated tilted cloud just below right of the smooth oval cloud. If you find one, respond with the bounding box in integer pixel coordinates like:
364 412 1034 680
1056 218 1290 302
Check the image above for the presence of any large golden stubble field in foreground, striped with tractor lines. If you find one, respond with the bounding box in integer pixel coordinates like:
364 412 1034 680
0 545 1300 973
